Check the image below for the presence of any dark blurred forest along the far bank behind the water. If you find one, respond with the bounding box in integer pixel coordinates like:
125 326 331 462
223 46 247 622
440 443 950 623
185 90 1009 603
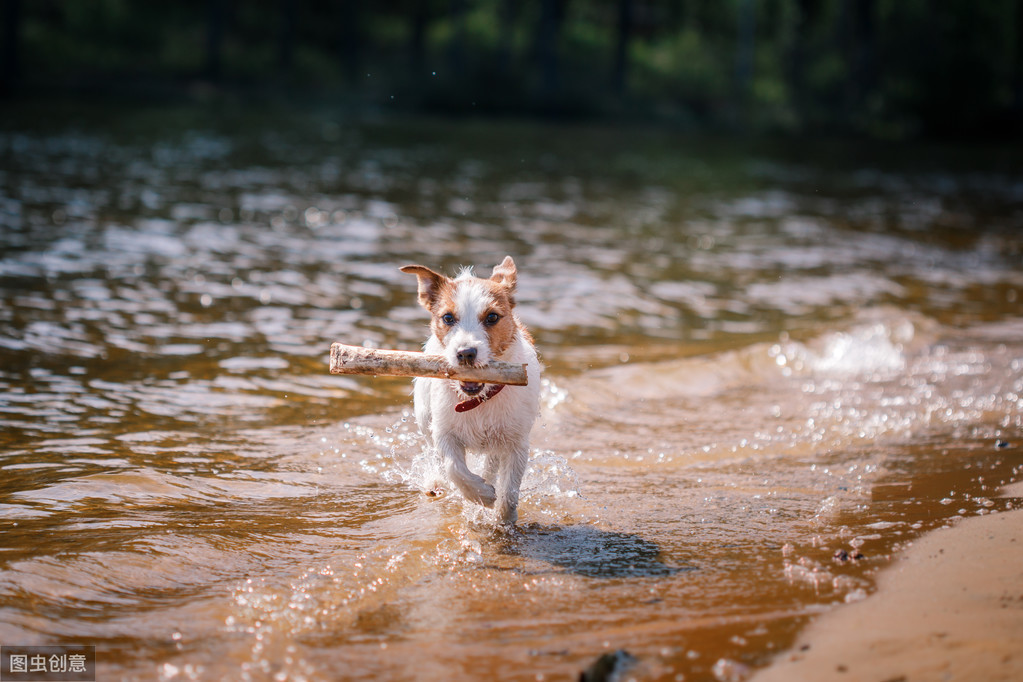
0 0 1023 139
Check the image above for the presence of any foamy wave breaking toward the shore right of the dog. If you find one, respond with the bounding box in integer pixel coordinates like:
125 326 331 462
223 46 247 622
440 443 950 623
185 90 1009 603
544 308 1023 463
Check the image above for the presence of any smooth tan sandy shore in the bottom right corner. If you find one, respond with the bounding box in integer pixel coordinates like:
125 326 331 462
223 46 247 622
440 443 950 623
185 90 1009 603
752 484 1023 682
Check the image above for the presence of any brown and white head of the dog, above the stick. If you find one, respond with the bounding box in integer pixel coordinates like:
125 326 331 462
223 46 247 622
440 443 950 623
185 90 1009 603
401 256 518 394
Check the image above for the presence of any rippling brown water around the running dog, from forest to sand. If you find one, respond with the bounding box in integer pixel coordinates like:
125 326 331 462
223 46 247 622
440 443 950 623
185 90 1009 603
0 112 1023 680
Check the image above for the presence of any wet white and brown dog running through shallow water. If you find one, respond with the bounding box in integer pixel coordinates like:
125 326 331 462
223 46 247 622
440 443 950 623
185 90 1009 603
401 256 540 526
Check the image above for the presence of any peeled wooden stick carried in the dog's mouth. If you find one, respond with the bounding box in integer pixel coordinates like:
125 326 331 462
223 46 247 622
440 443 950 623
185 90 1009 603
330 344 529 385
